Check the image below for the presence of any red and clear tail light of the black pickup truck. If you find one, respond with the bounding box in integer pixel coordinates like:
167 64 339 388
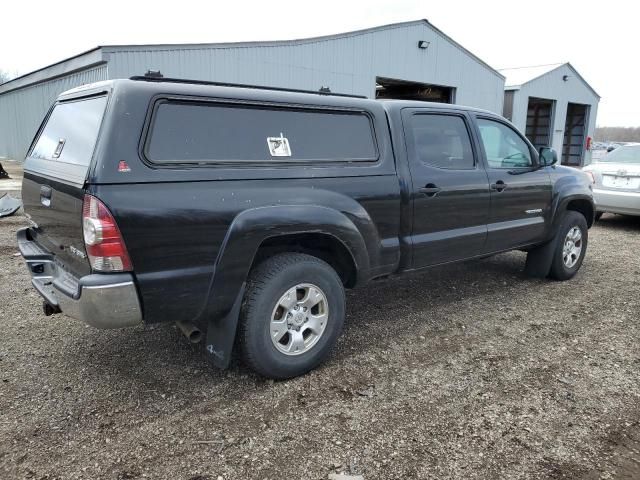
82 195 132 272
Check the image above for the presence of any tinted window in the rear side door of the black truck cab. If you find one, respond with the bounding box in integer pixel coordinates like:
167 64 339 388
411 114 475 170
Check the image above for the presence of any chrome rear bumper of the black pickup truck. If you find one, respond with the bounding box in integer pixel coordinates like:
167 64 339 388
18 228 142 329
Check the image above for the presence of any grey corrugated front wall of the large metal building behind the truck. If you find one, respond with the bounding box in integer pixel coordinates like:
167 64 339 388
105 23 504 113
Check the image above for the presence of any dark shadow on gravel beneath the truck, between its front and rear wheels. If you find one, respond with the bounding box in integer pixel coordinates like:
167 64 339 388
337 252 538 352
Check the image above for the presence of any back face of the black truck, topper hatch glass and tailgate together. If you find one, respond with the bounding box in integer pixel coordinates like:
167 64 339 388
22 95 107 276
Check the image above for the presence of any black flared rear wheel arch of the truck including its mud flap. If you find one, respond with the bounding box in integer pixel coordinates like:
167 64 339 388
198 205 370 368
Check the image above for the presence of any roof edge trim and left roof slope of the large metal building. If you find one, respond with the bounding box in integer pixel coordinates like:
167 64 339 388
0 19 504 95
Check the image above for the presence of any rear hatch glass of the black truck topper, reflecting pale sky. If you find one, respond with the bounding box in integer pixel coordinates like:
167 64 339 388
30 96 107 167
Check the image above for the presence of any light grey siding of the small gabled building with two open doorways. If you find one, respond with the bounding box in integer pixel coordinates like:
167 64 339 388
504 65 600 164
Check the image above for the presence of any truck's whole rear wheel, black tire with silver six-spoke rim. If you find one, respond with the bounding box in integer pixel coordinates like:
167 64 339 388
238 253 345 379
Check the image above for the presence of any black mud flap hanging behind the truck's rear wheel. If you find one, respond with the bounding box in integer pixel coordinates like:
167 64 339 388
205 283 246 368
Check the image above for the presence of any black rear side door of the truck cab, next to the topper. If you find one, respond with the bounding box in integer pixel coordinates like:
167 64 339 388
403 109 489 268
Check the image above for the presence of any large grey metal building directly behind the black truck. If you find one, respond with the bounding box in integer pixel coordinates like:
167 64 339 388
0 20 504 159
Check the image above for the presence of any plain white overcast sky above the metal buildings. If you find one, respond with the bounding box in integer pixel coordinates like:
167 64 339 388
0 0 640 126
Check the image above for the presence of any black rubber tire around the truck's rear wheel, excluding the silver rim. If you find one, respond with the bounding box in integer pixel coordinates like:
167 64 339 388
237 253 345 380
